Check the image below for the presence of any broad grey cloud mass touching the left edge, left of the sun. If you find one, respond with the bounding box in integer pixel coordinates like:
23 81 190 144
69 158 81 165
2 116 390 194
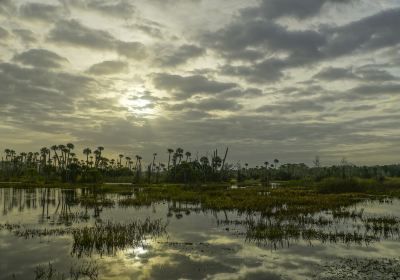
0 63 94 123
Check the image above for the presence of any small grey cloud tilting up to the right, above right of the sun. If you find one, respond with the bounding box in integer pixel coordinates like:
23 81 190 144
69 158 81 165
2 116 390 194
160 45 205 67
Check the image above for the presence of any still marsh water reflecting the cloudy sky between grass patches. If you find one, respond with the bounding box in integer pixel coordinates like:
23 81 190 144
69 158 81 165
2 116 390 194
0 188 400 279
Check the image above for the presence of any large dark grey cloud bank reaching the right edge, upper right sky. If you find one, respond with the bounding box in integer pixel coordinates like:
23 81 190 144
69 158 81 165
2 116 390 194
206 6 400 83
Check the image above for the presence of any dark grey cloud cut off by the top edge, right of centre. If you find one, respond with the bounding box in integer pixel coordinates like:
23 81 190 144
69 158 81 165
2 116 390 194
242 0 353 19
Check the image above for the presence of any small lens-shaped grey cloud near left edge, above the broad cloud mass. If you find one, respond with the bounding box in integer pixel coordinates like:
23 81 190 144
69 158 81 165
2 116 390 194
13 49 68 68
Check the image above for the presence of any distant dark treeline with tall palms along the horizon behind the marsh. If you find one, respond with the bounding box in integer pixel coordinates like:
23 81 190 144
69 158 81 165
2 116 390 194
0 143 400 189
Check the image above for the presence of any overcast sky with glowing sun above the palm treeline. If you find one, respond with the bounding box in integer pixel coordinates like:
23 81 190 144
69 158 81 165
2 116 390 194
0 0 400 165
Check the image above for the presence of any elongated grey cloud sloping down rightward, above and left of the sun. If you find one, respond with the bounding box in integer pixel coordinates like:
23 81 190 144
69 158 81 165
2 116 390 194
48 20 146 60
